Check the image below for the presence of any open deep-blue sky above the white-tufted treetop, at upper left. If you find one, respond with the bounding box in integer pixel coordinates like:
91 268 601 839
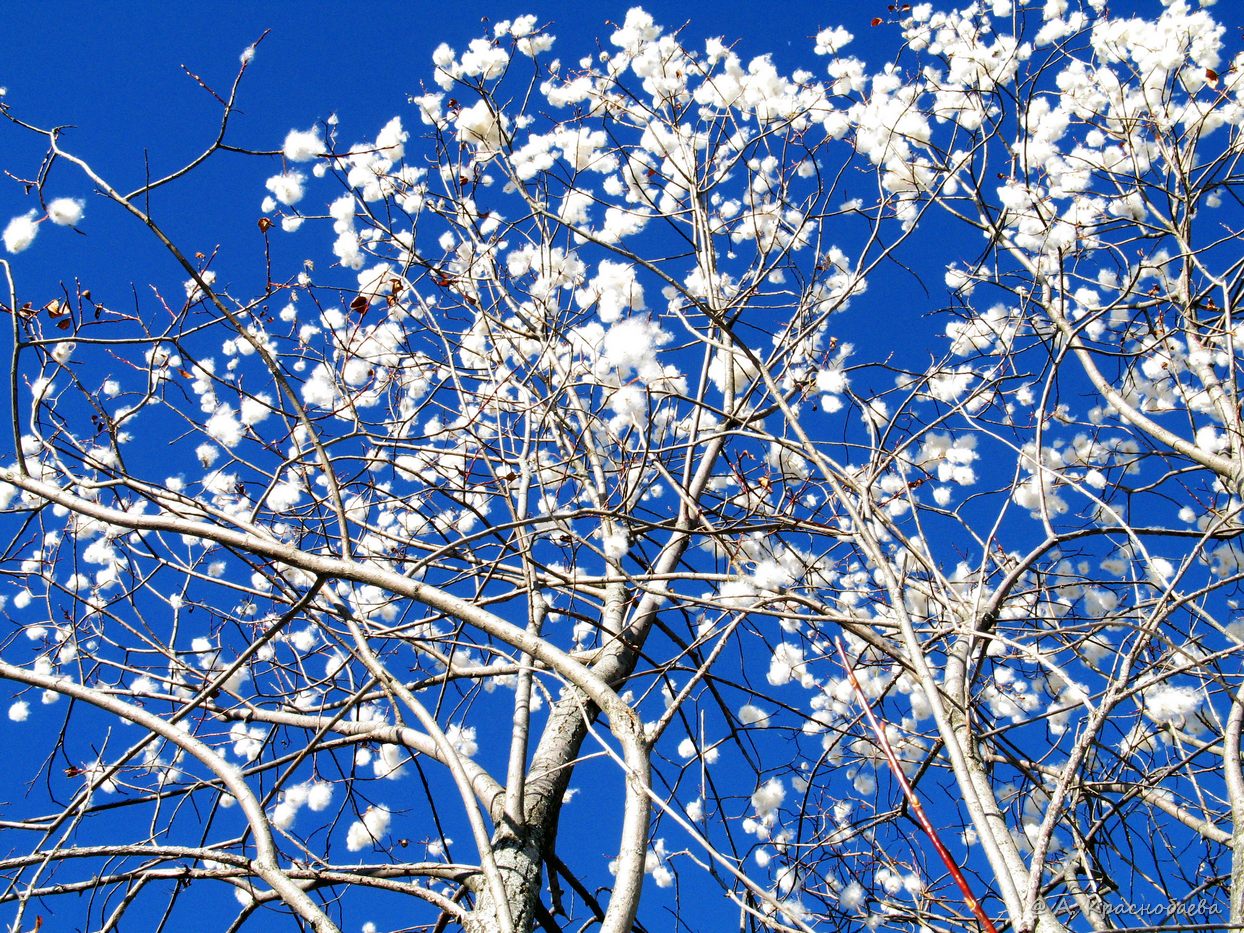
0 0 896 160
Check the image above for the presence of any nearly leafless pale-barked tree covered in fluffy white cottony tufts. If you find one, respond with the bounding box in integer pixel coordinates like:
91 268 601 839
0 0 1244 933
